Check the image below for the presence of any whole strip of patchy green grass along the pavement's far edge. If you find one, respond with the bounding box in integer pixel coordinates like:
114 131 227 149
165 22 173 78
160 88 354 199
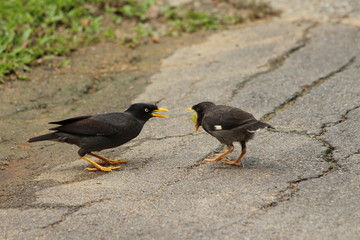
0 0 278 82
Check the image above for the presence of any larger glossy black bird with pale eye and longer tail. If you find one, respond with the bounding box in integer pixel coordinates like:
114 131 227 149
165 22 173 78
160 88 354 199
28 103 168 172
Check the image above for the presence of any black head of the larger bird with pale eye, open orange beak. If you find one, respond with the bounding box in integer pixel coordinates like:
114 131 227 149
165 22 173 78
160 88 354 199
125 103 169 121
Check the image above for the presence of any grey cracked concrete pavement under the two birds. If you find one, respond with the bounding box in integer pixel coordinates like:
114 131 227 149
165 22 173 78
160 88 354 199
0 0 360 239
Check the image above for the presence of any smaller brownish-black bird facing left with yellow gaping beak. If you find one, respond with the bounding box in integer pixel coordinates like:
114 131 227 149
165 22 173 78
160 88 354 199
188 102 273 167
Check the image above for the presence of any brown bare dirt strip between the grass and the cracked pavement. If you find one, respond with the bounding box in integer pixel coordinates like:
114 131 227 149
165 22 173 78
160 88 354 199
0 32 211 208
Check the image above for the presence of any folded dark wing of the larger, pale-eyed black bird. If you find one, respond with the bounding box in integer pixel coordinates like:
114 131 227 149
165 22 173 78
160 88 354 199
50 113 136 136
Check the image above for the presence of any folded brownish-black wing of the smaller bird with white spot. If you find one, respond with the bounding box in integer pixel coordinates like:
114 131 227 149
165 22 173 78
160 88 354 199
203 105 257 130
